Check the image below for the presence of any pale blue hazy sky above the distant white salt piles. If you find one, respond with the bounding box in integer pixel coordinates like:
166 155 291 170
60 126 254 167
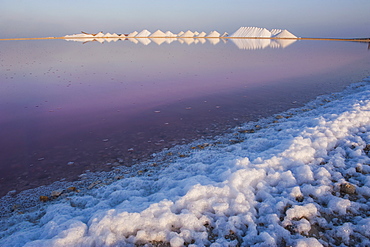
0 0 370 38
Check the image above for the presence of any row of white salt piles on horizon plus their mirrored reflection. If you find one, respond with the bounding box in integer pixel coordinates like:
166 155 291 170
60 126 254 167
64 27 297 50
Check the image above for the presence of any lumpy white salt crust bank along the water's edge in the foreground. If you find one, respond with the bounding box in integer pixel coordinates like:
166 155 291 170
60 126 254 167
0 78 370 247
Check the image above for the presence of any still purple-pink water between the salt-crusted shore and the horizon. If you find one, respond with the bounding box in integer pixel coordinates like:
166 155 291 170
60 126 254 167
0 40 370 196
